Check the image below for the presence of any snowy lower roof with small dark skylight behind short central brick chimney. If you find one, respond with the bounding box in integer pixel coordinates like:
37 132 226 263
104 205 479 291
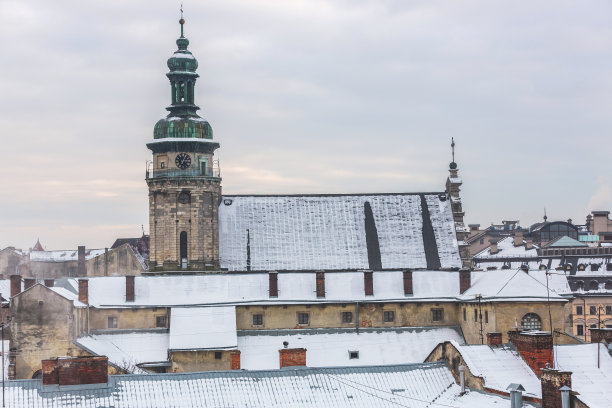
238 326 465 370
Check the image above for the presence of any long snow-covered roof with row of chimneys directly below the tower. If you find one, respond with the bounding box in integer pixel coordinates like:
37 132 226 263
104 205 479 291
74 271 459 307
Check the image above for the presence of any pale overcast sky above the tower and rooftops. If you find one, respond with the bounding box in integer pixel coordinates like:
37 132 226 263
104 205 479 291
0 0 612 249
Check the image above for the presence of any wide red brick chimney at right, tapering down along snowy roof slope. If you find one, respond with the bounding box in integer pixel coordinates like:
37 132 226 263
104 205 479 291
508 330 553 376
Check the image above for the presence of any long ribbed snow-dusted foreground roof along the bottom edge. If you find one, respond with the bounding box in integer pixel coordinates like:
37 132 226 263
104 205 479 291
6 362 510 408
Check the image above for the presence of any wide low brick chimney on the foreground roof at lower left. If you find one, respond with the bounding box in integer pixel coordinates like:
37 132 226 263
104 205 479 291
42 356 108 385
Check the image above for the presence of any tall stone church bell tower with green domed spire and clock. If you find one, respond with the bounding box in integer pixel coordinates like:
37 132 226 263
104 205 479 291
146 13 221 271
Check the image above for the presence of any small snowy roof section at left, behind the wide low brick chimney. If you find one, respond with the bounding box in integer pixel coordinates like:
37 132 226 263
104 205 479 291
74 331 169 373
